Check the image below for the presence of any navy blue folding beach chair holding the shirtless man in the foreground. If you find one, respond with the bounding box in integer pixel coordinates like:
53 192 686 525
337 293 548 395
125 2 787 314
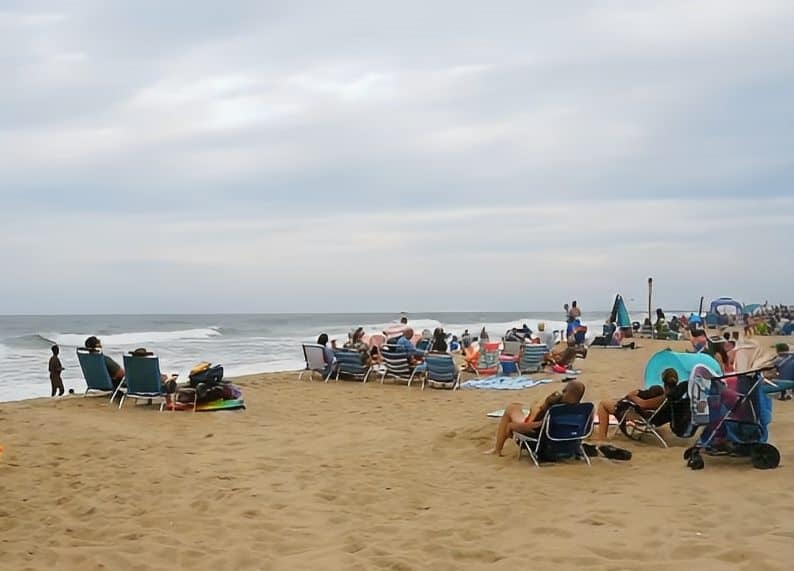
513 402 594 467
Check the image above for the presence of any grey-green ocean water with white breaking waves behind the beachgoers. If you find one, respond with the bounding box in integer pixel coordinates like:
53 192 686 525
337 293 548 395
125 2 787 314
0 310 620 401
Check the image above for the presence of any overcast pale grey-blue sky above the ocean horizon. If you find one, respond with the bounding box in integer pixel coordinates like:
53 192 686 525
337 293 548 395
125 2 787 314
0 0 794 314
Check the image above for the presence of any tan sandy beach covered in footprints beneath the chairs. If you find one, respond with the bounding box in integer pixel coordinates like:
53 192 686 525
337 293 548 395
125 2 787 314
0 337 794 571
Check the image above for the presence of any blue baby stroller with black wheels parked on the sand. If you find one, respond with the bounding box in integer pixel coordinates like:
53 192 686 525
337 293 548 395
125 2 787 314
684 365 780 470
